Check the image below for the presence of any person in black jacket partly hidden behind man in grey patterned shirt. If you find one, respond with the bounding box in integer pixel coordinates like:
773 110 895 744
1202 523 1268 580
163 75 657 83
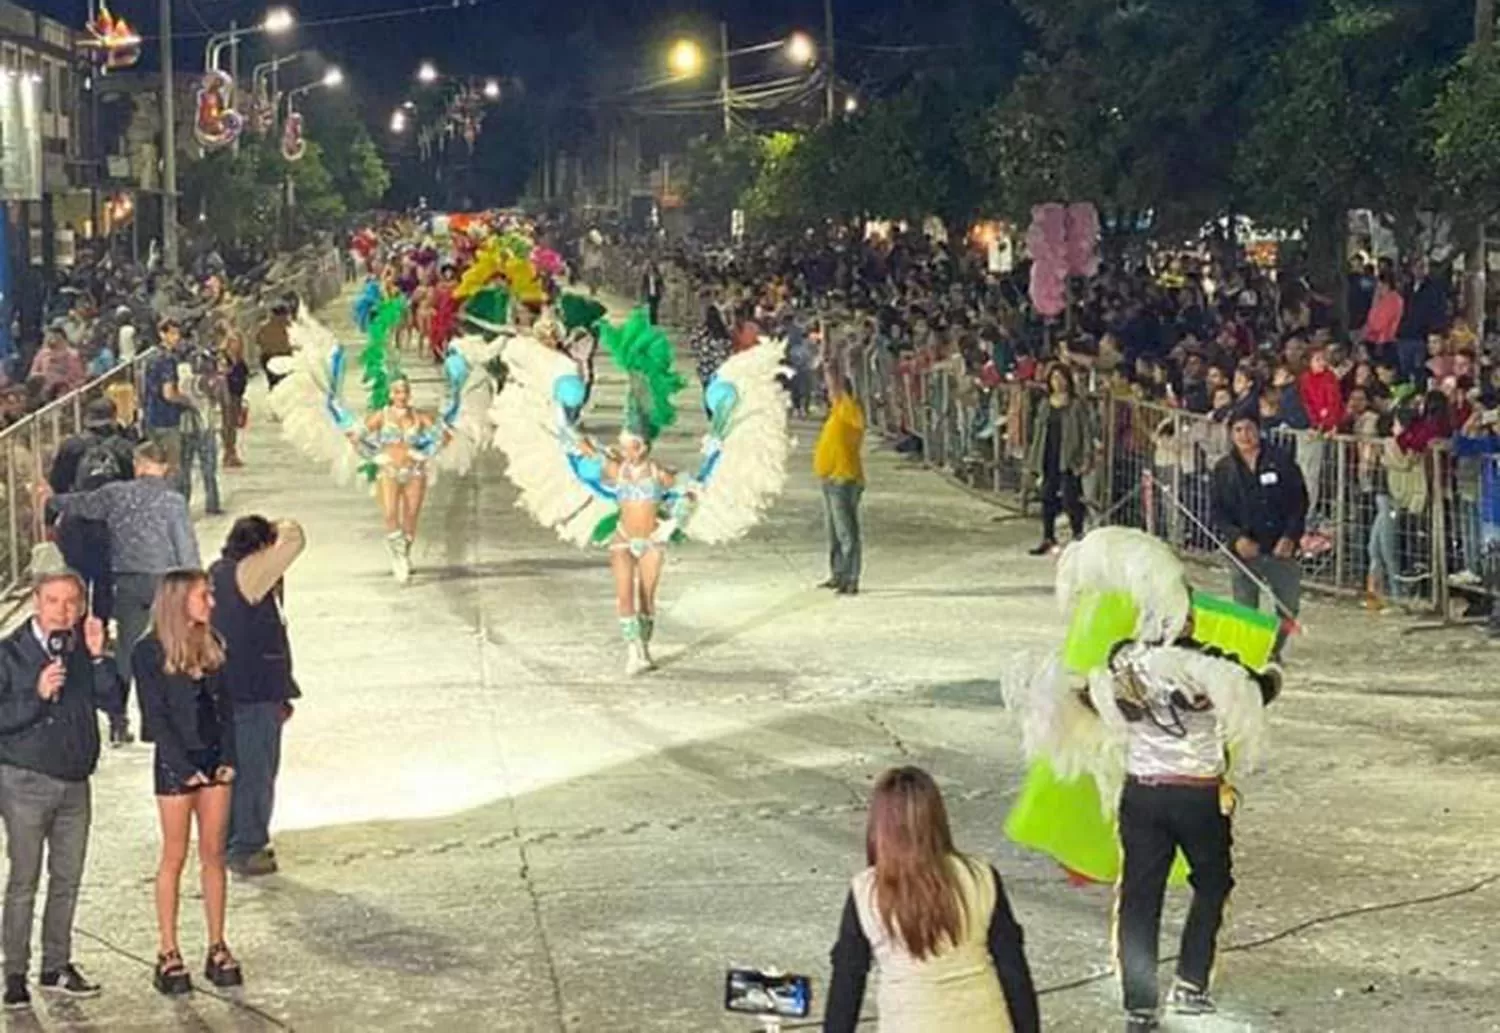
47 399 135 625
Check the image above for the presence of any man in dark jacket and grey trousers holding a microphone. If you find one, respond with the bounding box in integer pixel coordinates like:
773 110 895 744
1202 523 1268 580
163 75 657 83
0 571 125 1009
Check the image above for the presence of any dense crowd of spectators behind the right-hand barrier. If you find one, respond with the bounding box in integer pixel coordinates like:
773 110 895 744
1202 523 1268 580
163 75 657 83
614 229 1500 620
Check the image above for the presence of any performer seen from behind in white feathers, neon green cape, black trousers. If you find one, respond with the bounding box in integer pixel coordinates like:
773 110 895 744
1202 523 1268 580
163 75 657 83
1005 528 1281 1033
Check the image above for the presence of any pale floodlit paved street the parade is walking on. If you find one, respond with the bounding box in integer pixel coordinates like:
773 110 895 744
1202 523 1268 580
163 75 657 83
9 292 1500 1033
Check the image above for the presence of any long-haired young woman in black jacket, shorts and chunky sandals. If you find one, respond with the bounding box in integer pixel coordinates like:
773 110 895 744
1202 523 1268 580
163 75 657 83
131 570 243 994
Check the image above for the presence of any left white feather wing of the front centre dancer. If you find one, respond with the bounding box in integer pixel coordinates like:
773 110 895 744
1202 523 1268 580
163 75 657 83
489 337 614 546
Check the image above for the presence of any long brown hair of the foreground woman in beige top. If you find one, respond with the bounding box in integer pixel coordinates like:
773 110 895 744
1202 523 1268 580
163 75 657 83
866 768 966 960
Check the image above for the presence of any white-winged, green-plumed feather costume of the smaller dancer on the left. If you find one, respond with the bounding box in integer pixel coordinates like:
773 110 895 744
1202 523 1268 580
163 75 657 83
270 297 494 580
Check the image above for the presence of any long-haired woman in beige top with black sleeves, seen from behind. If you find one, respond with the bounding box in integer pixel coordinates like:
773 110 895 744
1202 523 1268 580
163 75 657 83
824 768 1041 1033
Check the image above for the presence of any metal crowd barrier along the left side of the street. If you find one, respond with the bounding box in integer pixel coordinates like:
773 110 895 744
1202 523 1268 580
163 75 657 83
0 252 344 600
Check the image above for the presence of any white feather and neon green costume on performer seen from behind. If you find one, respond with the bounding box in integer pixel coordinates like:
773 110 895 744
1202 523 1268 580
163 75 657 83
1002 528 1277 883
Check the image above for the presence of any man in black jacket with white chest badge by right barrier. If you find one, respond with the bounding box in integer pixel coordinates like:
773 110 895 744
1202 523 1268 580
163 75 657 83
1211 412 1308 658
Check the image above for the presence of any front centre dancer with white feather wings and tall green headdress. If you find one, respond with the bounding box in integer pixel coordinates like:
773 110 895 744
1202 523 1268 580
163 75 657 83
491 310 791 675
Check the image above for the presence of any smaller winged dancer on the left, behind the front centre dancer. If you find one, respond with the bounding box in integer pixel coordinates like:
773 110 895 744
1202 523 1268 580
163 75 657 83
270 298 492 583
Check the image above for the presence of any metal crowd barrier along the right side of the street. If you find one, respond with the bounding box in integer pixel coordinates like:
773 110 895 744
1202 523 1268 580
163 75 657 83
852 338 1470 615
